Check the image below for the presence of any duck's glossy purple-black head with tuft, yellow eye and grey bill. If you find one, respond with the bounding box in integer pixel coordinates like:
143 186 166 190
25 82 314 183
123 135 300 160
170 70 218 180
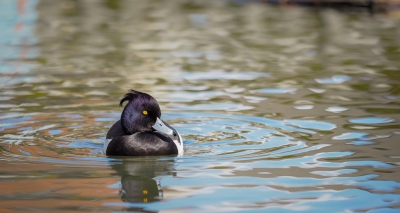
119 90 177 137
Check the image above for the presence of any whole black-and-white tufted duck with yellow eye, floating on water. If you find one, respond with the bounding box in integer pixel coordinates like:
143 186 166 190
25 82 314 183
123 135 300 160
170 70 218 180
104 90 183 156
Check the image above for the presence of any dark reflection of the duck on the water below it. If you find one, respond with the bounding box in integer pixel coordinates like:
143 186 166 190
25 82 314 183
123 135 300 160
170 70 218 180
110 156 176 212
